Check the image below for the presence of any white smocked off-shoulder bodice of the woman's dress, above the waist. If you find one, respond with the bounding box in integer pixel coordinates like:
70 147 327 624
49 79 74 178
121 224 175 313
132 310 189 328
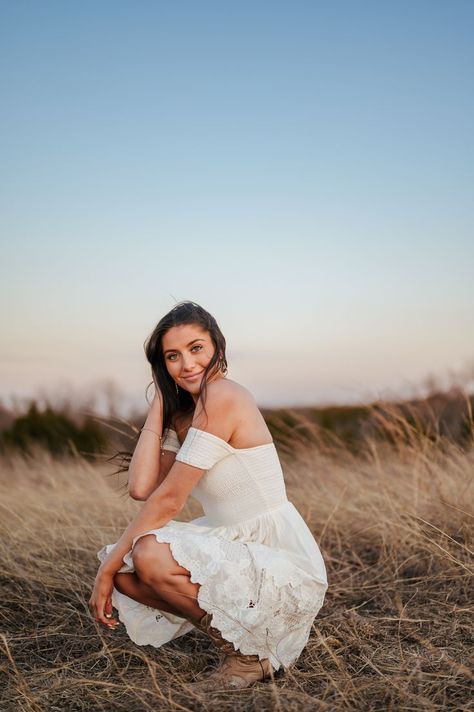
163 426 288 526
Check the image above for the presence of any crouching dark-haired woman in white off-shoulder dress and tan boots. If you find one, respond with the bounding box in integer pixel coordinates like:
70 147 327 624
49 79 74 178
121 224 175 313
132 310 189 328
89 302 327 689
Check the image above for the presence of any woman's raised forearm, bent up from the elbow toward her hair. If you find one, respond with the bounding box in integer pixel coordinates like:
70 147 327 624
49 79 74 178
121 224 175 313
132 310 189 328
128 389 163 500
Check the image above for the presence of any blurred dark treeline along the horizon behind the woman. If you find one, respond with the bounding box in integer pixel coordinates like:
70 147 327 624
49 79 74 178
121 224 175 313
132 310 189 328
0 388 474 459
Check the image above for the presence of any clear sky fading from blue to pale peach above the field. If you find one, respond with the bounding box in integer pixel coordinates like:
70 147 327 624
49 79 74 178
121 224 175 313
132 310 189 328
0 0 474 412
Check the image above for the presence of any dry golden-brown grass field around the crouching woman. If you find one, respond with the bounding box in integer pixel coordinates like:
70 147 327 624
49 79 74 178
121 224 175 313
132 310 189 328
0 404 474 712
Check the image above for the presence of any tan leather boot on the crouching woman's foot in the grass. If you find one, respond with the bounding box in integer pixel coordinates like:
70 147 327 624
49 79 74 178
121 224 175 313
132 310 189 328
192 613 273 691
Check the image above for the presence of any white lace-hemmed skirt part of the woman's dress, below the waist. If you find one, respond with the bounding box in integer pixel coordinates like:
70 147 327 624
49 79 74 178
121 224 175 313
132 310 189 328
98 502 328 670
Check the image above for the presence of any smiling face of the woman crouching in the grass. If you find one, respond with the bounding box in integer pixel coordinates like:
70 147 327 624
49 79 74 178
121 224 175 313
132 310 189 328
162 324 221 400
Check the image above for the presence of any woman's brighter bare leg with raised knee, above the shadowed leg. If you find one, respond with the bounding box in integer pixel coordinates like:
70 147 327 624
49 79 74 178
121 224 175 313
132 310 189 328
132 534 206 620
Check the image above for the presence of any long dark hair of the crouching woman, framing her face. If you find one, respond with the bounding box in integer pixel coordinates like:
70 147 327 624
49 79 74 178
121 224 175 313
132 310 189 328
111 301 227 474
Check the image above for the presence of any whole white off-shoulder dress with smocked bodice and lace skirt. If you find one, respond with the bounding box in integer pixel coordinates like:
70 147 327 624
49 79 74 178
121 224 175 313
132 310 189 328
98 426 328 670
